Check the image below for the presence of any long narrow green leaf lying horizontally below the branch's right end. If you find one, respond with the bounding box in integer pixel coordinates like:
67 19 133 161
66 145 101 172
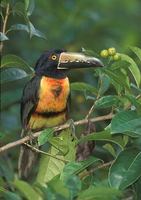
79 129 124 149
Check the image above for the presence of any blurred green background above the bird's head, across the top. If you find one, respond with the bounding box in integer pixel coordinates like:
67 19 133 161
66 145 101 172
5 0 141 58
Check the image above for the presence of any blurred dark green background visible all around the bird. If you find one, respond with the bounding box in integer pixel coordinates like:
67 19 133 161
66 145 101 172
0 0 141 143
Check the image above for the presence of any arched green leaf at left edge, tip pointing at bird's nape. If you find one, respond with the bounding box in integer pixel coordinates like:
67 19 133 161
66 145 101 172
1 54 33 73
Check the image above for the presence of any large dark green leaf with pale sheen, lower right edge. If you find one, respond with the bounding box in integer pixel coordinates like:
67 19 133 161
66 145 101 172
109 149 141 190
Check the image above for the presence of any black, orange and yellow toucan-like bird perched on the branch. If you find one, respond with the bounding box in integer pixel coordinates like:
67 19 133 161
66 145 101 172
18 49 103 179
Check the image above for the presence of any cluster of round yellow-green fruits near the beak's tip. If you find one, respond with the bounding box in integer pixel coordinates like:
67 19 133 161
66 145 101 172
100 47 120 61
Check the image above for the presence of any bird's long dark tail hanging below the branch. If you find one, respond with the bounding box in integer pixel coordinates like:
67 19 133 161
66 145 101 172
18 130 37 179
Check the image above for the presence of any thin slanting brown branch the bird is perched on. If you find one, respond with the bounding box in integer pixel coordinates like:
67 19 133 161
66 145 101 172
0 113 114 153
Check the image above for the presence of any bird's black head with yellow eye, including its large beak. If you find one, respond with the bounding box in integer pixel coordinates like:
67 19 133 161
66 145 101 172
35 49 103 78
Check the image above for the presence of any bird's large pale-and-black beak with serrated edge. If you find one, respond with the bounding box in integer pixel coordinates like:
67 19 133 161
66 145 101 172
57 52 104 69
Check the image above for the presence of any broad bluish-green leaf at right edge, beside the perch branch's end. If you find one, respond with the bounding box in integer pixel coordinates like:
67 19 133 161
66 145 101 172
111 111 141 136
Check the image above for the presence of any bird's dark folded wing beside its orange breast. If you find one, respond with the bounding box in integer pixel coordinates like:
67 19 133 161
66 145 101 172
21 76 41 129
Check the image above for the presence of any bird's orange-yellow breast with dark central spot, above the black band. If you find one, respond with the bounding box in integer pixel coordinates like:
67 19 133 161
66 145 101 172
35 76 70 113
